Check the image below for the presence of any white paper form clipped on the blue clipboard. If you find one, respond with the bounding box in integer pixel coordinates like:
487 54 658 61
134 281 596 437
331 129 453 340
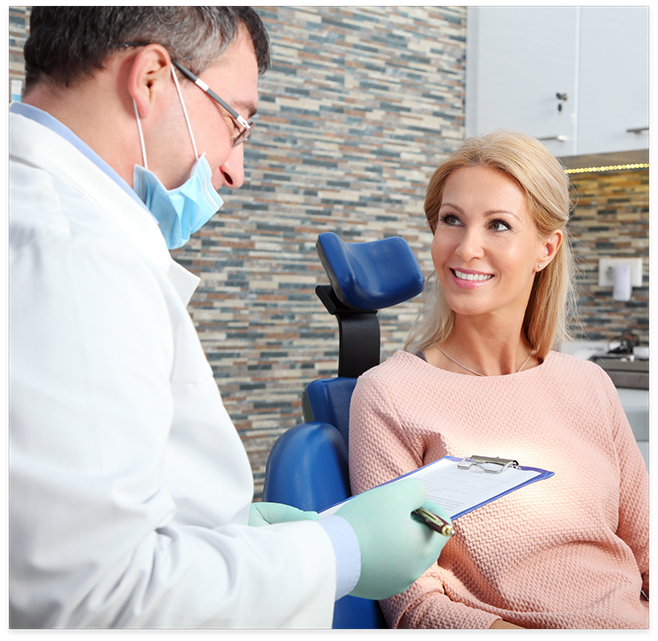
321 456 553 520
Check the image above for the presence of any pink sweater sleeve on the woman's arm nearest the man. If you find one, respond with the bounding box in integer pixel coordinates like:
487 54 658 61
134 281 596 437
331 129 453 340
349 375 500 628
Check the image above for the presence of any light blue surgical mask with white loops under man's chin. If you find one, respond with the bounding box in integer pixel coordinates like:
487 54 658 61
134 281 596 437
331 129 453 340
133 67 224 249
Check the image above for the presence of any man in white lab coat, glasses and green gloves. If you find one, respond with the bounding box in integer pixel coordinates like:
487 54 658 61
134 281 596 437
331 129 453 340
9 7 447 627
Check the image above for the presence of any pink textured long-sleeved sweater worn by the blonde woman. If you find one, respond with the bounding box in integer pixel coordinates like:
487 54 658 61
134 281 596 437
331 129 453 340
350 351 649 628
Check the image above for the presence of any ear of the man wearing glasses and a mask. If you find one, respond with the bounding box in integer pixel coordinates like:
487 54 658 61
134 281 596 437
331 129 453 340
128 44 171 119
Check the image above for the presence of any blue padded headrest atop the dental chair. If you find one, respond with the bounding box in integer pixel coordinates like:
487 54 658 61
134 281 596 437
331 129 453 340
316 232 425 310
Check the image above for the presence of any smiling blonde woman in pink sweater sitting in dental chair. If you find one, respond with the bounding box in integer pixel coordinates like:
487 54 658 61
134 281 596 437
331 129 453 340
350 131 649 628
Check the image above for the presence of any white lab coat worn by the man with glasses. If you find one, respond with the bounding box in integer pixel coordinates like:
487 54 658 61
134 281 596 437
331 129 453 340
9 114 336 627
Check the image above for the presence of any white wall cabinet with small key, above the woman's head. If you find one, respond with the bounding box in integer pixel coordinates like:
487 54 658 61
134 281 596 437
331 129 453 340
466 6 649 157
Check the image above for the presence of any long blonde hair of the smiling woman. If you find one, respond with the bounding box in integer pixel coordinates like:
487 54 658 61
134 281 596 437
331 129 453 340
404 131 576 360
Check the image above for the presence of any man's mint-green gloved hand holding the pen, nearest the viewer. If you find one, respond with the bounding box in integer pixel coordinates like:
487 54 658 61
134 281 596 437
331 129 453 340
336 479 451 600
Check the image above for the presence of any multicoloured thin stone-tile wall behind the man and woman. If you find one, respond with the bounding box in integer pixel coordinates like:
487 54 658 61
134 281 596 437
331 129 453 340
9 7 649 496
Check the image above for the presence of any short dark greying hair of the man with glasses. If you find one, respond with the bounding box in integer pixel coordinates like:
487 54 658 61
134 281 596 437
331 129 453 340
24 6 270 92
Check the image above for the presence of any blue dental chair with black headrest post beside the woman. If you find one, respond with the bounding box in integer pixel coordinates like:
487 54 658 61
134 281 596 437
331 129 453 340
263 232 425 628
